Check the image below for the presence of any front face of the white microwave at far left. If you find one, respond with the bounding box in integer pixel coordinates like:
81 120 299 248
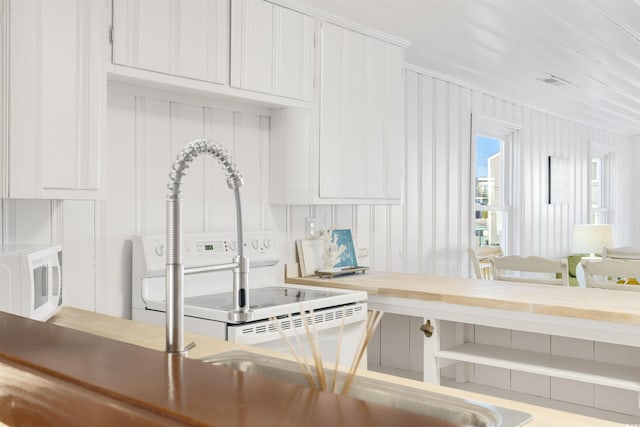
23 246 62 320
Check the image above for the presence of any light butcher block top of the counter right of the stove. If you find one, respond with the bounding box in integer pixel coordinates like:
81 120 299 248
286 271 640 324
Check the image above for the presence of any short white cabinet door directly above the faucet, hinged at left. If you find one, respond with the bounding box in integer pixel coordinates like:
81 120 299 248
112 0 230 84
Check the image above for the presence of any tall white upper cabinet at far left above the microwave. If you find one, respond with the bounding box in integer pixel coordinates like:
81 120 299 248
0 0 107 199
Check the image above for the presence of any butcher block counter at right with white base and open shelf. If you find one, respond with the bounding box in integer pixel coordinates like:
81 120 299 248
286 269 640 422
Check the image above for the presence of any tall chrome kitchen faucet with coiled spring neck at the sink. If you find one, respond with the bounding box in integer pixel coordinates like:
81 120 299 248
166 139 249 355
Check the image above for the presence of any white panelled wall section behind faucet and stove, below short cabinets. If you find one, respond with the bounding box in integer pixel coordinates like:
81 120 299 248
96 84 273 317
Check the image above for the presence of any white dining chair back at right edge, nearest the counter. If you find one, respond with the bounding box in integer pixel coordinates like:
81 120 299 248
580 258 640 291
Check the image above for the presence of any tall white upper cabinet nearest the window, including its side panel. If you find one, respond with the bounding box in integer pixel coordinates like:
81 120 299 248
270 22 405 204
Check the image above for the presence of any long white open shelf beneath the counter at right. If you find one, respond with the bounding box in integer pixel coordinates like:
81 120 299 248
436 343 640 391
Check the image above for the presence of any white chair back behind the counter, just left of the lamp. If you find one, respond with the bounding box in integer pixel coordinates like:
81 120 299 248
490 255 569 286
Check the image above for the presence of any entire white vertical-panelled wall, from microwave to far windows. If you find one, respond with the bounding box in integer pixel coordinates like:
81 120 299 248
2 67 640 316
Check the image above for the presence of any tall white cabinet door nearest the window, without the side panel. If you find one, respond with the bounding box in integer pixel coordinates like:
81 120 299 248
319 22 404 200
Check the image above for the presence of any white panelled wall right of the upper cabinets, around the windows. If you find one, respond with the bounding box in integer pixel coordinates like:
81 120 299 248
286 70 638 276
